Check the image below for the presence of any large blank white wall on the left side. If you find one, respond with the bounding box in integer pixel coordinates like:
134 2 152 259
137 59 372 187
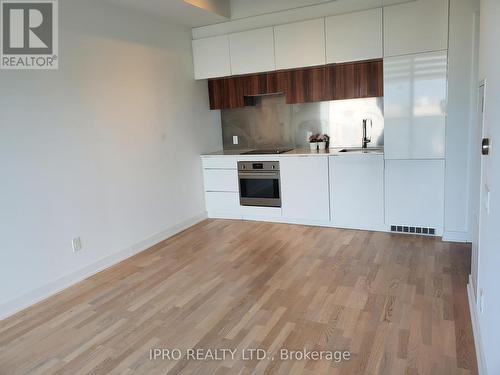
0 0 222 316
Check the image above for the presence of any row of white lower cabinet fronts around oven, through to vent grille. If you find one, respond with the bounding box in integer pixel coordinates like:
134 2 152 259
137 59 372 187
203 154 445 235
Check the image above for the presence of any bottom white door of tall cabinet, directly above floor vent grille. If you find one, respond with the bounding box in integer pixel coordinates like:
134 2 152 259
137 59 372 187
385 160 444 228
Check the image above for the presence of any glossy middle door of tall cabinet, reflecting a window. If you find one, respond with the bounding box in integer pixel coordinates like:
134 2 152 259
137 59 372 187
384 52 447 159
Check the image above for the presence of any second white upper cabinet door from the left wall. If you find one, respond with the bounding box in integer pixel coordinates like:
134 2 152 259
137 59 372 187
229 27 276 74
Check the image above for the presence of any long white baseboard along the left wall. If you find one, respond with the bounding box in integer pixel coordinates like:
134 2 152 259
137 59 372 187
0 214 207 320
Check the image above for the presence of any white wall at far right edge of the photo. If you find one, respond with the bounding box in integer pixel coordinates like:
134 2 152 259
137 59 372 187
475 0 500 375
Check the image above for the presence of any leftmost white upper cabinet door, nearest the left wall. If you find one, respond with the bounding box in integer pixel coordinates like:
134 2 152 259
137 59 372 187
193 35 231 79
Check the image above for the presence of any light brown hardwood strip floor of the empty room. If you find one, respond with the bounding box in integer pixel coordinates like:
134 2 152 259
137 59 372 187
0 220 477 375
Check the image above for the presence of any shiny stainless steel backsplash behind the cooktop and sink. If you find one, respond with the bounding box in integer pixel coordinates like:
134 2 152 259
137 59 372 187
222 95 384 150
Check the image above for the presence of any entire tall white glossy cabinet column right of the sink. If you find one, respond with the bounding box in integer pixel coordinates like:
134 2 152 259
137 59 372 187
384 0 448 234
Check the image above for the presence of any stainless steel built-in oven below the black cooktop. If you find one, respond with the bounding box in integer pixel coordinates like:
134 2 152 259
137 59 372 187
238 161 281 207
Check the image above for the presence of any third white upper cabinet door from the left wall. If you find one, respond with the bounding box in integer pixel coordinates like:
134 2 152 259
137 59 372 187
274 18 326 69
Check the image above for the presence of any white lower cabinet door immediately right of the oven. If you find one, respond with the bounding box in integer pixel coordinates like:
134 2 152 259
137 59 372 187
280 156 330 222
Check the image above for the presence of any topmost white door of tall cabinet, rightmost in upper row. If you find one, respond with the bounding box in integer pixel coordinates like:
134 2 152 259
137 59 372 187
384 0 448 56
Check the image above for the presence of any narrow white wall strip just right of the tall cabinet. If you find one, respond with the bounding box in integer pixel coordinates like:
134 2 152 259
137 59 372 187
444 0 479 241
